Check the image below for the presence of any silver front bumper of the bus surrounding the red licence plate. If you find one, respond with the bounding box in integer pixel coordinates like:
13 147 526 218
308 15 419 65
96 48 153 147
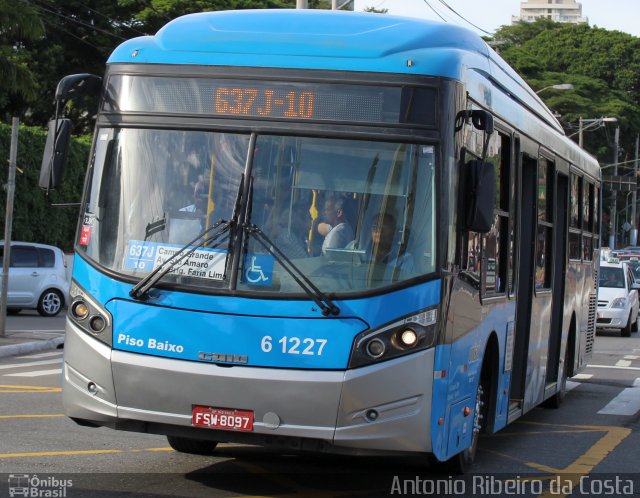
63 322 434 452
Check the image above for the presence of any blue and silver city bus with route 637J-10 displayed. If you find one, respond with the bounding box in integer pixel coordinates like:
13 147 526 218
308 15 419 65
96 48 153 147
41 10 600 471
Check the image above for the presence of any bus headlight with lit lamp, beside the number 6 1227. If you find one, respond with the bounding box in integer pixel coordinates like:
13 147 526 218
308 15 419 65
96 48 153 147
349 308 437 368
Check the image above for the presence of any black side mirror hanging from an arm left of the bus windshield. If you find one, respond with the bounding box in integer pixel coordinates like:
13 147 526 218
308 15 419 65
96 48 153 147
38 119 73 191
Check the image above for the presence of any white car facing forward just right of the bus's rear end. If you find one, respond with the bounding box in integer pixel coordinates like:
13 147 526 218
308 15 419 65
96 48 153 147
596 258 640 337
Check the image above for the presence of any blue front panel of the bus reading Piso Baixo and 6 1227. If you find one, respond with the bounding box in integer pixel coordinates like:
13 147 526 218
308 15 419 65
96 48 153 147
74 256 440 369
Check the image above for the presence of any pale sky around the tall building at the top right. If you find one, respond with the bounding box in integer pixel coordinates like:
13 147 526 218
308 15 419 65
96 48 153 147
354 0 640 37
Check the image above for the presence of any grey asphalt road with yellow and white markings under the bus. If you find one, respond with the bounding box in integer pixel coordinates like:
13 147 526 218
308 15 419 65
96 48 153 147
0 316 640 497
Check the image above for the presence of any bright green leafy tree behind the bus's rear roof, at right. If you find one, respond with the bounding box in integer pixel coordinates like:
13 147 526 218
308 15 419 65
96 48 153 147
492 19 640 167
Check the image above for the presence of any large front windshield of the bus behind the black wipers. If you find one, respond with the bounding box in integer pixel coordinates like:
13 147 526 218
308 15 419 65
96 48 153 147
78 128 436 293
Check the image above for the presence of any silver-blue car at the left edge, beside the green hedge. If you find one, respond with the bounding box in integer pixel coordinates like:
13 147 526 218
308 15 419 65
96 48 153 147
0 241 69 316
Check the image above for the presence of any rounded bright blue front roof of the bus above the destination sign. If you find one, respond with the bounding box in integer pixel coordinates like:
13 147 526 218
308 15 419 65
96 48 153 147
108 9 489 79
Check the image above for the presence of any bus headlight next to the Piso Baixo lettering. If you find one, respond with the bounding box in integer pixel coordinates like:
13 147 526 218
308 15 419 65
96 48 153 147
67 280 113 346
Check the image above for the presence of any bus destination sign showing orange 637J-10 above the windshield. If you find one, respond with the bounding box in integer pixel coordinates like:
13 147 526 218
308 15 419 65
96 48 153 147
103 74 436 125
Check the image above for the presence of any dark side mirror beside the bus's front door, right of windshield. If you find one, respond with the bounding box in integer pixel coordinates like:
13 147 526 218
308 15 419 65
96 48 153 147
464 160 496 233
